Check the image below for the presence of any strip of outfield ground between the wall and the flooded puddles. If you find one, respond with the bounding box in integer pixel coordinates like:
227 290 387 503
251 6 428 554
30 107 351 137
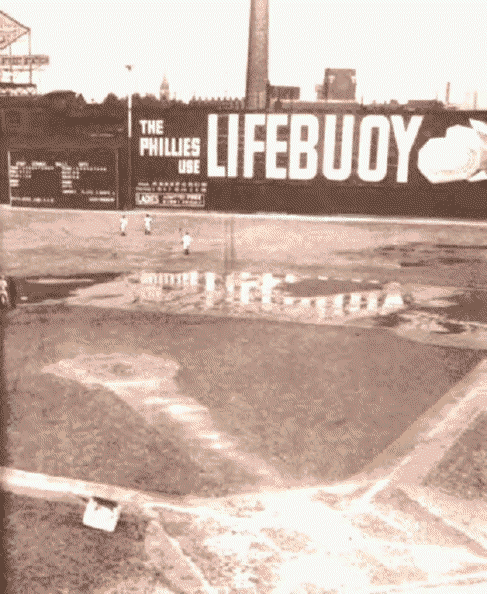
0 208 487 285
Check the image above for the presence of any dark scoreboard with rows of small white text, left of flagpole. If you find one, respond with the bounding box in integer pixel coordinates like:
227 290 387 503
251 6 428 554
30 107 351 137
8 149 118 209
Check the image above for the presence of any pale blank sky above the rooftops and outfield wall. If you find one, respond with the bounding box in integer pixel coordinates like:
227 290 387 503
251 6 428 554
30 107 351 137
0 0 487 108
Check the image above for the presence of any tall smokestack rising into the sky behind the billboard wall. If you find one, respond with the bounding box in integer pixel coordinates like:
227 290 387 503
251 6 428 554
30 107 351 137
245 0 269 109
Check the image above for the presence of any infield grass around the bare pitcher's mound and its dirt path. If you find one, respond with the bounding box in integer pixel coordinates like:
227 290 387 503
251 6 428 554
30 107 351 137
5 305 486 495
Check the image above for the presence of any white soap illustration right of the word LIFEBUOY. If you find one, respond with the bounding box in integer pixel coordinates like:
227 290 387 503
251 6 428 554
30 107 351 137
418 120 487 184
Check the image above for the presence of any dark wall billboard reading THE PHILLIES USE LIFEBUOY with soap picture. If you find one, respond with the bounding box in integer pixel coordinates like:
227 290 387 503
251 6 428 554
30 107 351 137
132 108 487 216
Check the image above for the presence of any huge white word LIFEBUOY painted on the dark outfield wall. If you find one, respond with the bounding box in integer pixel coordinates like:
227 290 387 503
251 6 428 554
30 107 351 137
207 113 424 183
